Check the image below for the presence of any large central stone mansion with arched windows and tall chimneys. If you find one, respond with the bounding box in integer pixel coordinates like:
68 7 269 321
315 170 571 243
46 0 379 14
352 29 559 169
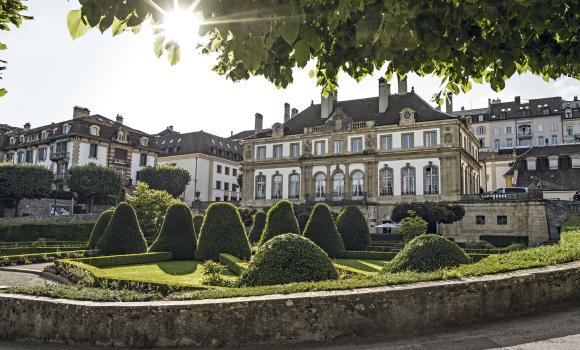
241 79 480 221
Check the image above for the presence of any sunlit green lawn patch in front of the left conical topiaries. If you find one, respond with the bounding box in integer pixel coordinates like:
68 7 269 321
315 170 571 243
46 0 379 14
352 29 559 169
100 260 234 287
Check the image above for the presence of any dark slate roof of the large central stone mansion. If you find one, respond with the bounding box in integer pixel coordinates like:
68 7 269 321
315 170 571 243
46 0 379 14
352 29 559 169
249 91 457 138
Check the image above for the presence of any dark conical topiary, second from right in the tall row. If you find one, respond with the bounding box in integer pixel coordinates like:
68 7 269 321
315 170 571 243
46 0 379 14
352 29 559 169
304 203 344 258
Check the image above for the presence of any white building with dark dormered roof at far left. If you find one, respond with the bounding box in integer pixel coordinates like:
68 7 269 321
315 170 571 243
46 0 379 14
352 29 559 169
0 107 157 187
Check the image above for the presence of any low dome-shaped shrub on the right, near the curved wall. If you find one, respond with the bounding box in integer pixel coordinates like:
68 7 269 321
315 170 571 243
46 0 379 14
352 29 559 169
390 234 470 272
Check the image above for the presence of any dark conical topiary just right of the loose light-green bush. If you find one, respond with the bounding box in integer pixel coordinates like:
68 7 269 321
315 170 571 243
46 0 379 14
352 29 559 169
149 203 197 260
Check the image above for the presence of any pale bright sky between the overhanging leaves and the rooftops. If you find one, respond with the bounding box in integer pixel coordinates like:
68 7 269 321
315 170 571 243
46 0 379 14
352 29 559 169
0 0 580 136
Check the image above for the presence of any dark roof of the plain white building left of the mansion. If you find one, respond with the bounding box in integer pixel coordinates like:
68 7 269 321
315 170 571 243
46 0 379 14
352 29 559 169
155 130 242 161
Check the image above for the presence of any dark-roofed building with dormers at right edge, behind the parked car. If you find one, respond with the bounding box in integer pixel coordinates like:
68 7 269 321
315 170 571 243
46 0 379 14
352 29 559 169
504 144 580 200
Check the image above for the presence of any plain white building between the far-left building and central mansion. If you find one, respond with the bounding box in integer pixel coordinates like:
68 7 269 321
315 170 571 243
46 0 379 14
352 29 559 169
155 126 242 206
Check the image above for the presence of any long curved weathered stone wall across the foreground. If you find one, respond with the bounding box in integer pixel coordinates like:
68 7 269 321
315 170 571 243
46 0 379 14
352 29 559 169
0 262 580 347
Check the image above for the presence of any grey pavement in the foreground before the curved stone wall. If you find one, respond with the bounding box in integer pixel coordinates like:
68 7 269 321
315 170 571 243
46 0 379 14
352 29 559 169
0 306 580 350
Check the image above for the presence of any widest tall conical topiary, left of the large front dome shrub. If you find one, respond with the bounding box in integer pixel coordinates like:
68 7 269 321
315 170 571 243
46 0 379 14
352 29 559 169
195 203 252 261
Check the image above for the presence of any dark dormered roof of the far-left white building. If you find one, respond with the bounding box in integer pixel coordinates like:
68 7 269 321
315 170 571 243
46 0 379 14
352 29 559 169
0 114 153 150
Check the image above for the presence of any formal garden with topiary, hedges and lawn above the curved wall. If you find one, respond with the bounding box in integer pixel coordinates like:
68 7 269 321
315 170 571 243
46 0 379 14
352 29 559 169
0 176 580 301
